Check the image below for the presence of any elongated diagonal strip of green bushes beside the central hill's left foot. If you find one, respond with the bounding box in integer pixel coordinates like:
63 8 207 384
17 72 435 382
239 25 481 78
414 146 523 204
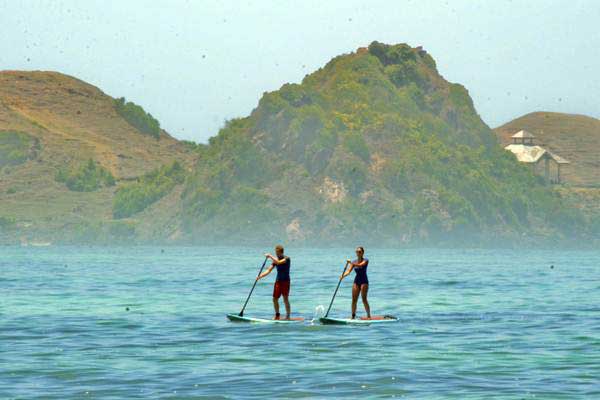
113 161 185 218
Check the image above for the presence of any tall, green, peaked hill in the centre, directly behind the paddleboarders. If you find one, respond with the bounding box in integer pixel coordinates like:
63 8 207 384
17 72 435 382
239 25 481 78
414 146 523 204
183 42 591 245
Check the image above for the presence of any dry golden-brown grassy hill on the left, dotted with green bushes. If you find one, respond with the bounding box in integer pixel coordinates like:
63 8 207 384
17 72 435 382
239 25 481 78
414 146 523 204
0 71 193 242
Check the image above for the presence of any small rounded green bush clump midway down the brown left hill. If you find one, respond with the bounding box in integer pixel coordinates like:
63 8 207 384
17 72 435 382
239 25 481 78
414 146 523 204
55 159 115 192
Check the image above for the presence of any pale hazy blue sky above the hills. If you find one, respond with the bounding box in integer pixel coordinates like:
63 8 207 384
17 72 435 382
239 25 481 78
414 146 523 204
0 0 600 142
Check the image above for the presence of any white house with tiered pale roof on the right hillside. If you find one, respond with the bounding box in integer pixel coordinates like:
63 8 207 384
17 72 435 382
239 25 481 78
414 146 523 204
504 130 570 183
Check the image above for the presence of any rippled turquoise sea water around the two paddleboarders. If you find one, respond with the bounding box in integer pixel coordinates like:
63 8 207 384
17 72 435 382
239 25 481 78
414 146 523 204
0 247 600 399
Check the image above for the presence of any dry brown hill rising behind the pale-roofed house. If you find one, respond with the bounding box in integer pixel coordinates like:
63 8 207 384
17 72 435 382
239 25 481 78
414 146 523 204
495 112 600 188
